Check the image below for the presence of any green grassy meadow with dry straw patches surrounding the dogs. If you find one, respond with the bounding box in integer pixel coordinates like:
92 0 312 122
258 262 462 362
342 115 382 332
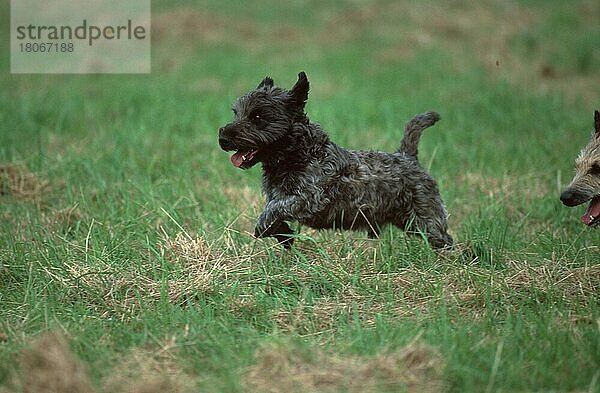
0 0 600 393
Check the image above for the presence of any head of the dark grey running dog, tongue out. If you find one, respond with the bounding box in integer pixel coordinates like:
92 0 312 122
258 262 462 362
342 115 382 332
219 72 309 169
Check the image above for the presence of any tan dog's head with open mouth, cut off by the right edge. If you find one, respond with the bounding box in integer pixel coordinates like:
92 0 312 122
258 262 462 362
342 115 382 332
560 111 600 226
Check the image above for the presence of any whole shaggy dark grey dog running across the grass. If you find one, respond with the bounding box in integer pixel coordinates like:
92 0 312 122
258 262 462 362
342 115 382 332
219 72 452 248
